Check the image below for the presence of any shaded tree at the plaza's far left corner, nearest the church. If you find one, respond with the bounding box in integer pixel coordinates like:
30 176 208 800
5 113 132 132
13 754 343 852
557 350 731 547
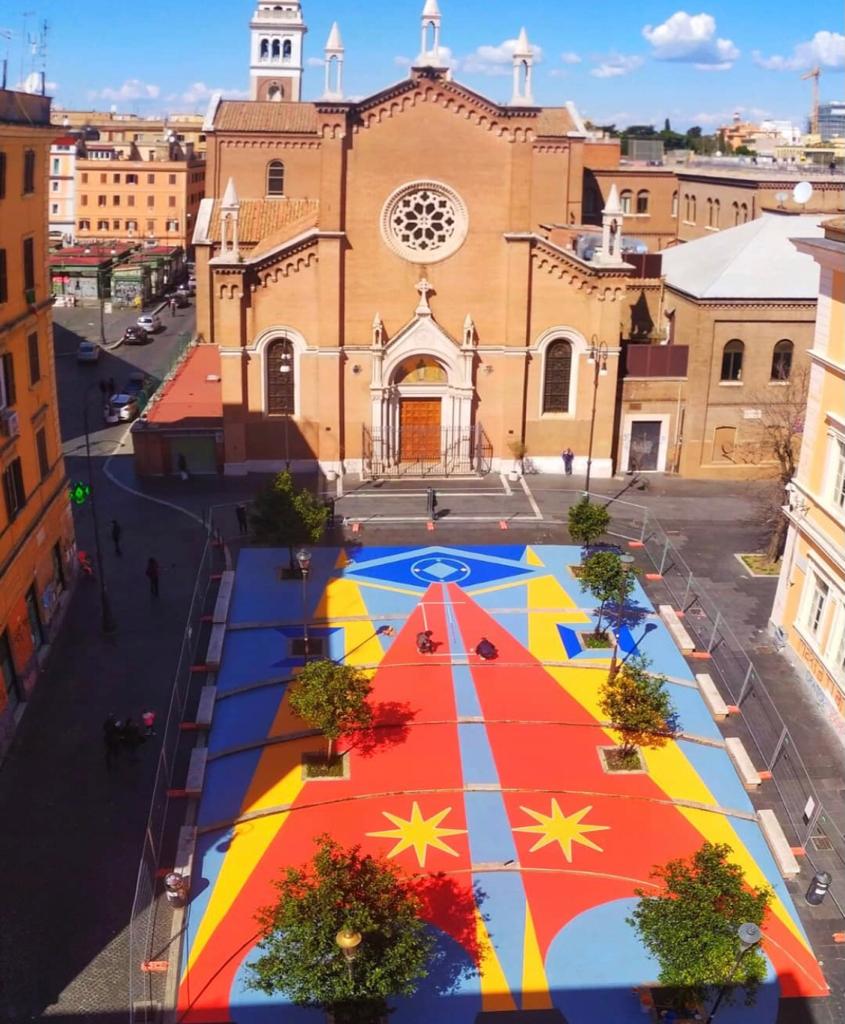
250 470 329 571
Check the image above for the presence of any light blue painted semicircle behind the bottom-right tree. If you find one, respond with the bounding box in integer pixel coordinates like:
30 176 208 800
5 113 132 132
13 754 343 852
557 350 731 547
546 899 778 1024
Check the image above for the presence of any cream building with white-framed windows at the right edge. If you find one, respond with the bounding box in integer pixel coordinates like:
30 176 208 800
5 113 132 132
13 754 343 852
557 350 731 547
771 217 845 715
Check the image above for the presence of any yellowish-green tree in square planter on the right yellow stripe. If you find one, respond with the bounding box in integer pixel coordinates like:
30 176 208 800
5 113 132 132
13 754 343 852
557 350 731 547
599 654 677 758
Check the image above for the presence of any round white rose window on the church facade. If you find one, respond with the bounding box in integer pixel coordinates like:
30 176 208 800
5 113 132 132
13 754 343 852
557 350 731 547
381 181 469 263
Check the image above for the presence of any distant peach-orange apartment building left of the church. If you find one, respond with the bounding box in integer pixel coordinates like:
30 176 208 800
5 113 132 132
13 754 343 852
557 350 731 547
76 138 205 249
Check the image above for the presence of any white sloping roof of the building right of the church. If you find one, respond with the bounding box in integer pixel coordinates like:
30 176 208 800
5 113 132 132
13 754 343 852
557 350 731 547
663 210 830 299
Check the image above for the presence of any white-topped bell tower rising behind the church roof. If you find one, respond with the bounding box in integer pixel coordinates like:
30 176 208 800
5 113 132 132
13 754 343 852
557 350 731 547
250 0 308 100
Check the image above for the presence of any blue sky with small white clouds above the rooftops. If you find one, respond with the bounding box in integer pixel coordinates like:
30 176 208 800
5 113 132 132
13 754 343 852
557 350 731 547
0 0 845 130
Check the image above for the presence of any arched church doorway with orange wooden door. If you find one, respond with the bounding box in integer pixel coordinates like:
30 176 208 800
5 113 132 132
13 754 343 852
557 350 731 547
391 355 449 463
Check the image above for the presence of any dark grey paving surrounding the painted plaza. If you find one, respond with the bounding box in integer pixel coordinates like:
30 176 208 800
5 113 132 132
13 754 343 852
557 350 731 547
0 458 845 1024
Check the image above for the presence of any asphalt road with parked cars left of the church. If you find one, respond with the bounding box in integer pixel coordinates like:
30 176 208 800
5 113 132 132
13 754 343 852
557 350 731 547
53 303 197 456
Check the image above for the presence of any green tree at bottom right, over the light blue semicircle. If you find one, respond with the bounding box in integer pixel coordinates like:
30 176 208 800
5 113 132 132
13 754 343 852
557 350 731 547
627 843 772 1009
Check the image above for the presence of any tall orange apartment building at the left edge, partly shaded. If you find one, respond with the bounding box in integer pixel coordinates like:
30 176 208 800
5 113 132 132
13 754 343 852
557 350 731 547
0 90 75 757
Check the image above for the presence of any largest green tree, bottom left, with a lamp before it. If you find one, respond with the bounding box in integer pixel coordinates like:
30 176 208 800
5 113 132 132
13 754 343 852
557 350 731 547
247 836 434 1024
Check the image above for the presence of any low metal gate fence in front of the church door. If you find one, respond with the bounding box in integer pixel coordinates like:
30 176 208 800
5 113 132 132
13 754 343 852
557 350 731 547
362 423 493 479
